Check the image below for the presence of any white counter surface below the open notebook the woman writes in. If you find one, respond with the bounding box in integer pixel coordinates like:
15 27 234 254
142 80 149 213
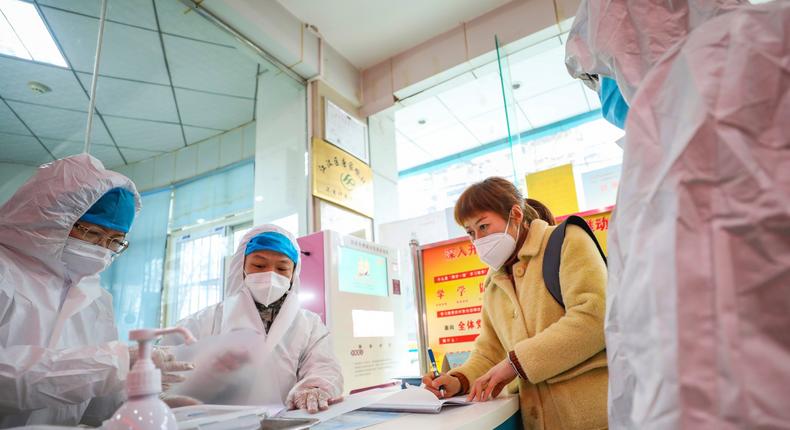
367 393 519 430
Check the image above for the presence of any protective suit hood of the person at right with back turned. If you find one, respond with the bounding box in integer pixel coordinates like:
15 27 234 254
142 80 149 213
565 0 749 104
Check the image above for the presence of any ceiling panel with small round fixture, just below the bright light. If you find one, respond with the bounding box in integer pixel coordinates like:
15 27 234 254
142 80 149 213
0 57 88 110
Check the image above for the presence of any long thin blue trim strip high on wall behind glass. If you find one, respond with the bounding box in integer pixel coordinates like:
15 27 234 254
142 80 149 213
398 109 602 179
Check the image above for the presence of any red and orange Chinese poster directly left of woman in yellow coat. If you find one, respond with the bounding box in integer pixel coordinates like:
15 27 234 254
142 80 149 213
421 238 488 363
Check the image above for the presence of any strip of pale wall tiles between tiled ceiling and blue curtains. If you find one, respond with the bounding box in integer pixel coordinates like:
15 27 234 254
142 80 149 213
115 122 255 191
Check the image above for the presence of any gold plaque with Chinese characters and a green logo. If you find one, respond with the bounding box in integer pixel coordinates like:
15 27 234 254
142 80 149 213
312 138 373 217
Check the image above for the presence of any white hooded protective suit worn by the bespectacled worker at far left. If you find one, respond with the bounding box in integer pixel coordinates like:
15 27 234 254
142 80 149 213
0 155 140 427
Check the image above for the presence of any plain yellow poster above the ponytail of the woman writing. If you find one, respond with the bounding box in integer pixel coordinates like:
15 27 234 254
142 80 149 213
527 164 579 215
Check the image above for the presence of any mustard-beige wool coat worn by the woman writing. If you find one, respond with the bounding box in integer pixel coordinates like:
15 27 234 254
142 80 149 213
451 220 608 430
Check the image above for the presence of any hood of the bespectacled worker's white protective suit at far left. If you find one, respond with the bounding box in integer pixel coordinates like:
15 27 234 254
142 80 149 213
0 154 140 276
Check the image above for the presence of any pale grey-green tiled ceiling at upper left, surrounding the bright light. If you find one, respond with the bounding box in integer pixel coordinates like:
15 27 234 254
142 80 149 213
0 0 257 167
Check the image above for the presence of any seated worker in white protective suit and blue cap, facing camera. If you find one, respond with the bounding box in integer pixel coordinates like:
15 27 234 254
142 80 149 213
162 225 343 413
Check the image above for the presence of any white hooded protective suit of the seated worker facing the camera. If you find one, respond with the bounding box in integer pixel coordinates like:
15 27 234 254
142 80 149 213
161 225 343 404
